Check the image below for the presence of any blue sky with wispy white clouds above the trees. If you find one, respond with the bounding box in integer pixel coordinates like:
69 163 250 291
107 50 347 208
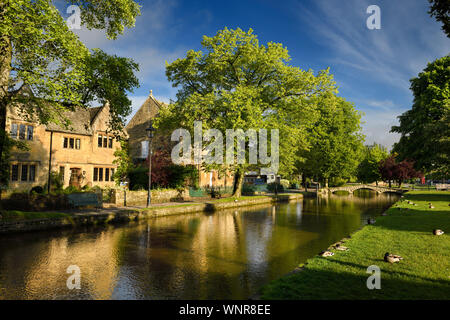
66 0 450 147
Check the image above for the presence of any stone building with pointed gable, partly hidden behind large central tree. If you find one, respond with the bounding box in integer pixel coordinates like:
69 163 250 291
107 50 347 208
126 90 233 187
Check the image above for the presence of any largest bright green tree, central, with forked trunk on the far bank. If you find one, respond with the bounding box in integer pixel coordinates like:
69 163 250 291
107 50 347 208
156 28 335 196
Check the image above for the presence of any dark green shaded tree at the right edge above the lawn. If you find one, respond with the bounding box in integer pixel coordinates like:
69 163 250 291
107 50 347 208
391 56 450 178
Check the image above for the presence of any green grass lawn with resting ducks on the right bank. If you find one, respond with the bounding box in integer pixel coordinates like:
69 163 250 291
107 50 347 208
261 191 450 299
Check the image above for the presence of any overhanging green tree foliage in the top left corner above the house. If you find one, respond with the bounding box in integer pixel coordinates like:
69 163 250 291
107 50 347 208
0 0 140 190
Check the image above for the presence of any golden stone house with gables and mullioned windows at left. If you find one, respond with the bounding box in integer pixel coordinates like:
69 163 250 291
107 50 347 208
6 104 120 191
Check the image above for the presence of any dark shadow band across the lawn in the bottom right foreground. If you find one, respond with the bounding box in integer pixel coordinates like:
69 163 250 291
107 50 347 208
261 268 450 300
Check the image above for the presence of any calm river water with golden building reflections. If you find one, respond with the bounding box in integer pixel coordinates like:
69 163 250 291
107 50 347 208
0 190 398 299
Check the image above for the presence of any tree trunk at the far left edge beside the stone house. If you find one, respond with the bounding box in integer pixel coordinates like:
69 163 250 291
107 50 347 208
0 33 12 200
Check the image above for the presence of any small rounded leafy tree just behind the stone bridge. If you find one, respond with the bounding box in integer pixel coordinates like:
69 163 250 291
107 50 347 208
357 143 389 185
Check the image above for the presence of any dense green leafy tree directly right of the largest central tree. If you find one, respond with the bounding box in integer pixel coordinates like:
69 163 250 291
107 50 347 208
297 94 363 186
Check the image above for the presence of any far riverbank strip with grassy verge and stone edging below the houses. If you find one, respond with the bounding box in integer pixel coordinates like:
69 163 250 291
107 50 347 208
0 194 303 234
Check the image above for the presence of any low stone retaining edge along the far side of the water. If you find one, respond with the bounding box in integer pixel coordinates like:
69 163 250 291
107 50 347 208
0 194 303 234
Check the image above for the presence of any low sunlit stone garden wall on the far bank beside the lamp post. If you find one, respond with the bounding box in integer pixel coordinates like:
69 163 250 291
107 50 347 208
111 189 189 206
